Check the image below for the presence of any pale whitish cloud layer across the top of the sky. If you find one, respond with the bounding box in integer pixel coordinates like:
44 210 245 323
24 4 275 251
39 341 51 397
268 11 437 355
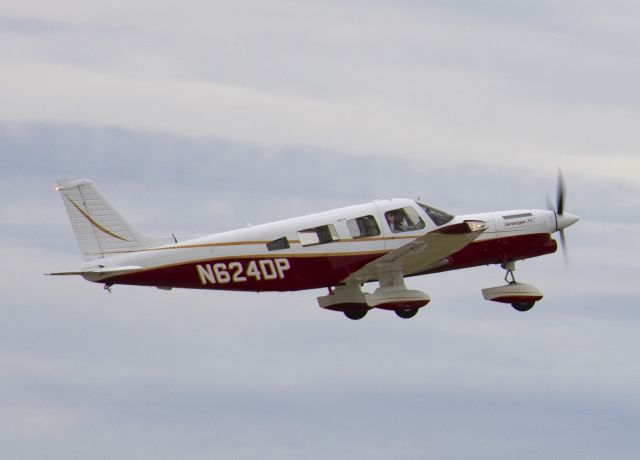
0 2 640 183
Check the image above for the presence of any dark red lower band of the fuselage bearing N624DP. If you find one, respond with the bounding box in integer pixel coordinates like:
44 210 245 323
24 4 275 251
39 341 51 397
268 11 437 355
100 233 557 292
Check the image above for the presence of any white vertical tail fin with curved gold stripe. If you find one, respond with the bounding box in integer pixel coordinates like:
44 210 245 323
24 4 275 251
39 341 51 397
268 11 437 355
56 179 169 261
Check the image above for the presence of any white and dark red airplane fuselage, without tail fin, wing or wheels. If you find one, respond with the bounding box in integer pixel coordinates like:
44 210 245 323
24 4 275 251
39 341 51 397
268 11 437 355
83 199 558 292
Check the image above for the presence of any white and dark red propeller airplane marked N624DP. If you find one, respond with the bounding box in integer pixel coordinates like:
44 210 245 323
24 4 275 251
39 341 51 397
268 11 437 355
48 174 579 320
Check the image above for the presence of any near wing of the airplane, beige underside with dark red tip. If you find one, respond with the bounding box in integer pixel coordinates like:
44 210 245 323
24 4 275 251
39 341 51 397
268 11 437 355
344 221 489 284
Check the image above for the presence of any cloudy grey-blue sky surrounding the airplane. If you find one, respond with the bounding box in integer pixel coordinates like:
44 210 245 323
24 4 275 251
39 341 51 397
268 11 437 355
0 0 640 459
